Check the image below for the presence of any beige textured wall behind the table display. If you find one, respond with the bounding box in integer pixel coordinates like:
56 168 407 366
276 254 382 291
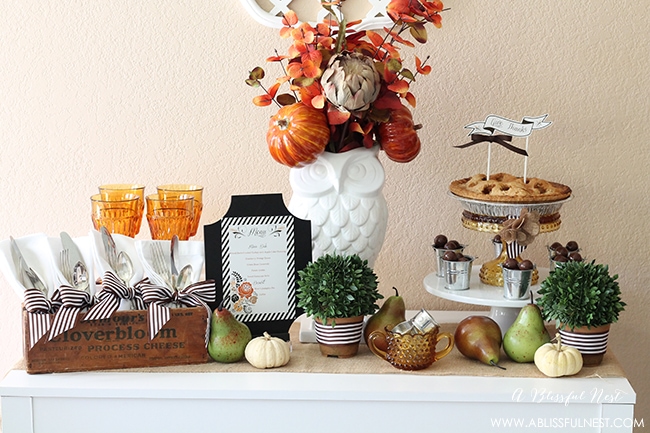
0 0 650 421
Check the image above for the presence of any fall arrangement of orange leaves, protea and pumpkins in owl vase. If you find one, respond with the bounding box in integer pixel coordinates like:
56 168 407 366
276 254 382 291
246 0 443 167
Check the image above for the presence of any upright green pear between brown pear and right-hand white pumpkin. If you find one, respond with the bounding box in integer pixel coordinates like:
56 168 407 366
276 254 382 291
503 292 551 362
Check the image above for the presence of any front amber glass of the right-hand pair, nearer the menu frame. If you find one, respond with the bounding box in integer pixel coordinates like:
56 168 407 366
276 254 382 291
146 194 194 241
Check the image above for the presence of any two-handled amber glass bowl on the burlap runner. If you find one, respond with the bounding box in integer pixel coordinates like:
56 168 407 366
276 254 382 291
368 326 454 370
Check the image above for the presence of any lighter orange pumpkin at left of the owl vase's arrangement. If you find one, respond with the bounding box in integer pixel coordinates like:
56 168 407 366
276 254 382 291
266 102 330 167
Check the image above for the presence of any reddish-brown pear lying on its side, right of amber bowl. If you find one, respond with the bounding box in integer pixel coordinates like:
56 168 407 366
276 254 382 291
454 316 505 370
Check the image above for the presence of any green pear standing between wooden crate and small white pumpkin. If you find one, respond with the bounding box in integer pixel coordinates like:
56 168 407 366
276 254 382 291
208 305 252 362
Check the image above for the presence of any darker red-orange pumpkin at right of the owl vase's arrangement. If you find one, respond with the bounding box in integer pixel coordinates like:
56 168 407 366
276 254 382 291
377 105 421 162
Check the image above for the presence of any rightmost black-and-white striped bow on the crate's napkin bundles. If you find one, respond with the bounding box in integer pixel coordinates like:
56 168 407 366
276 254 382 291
141 279 217 347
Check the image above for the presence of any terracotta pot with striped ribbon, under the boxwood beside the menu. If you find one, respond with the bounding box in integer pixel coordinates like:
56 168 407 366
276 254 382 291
314 316 363 358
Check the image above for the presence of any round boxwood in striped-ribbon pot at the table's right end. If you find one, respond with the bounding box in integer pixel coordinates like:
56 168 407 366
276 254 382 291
537 261 626 365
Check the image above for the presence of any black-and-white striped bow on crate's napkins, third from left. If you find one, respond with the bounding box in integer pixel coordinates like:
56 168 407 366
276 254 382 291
83 271 144 322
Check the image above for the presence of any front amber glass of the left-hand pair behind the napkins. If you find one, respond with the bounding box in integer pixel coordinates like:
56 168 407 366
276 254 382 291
90 194 140 237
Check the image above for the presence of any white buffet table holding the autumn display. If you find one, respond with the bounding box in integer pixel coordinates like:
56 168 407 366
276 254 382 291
0 312 636 433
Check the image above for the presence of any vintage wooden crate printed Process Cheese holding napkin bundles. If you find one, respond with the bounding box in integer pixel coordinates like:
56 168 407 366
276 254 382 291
23 307 208 373
